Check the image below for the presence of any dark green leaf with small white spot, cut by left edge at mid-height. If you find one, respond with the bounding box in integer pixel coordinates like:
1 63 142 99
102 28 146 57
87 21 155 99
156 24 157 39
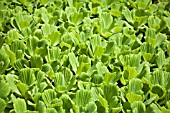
0 52 10 74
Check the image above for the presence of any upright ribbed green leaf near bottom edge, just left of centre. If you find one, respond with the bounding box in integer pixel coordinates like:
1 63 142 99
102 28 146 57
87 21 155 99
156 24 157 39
76 90 92 107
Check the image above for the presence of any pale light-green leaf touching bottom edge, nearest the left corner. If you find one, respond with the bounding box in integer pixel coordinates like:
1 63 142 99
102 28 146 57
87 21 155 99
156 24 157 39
13 98 27 113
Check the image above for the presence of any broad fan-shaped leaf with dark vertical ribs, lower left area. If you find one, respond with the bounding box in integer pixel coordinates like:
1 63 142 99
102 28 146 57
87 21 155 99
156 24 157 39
19 68 35 86
